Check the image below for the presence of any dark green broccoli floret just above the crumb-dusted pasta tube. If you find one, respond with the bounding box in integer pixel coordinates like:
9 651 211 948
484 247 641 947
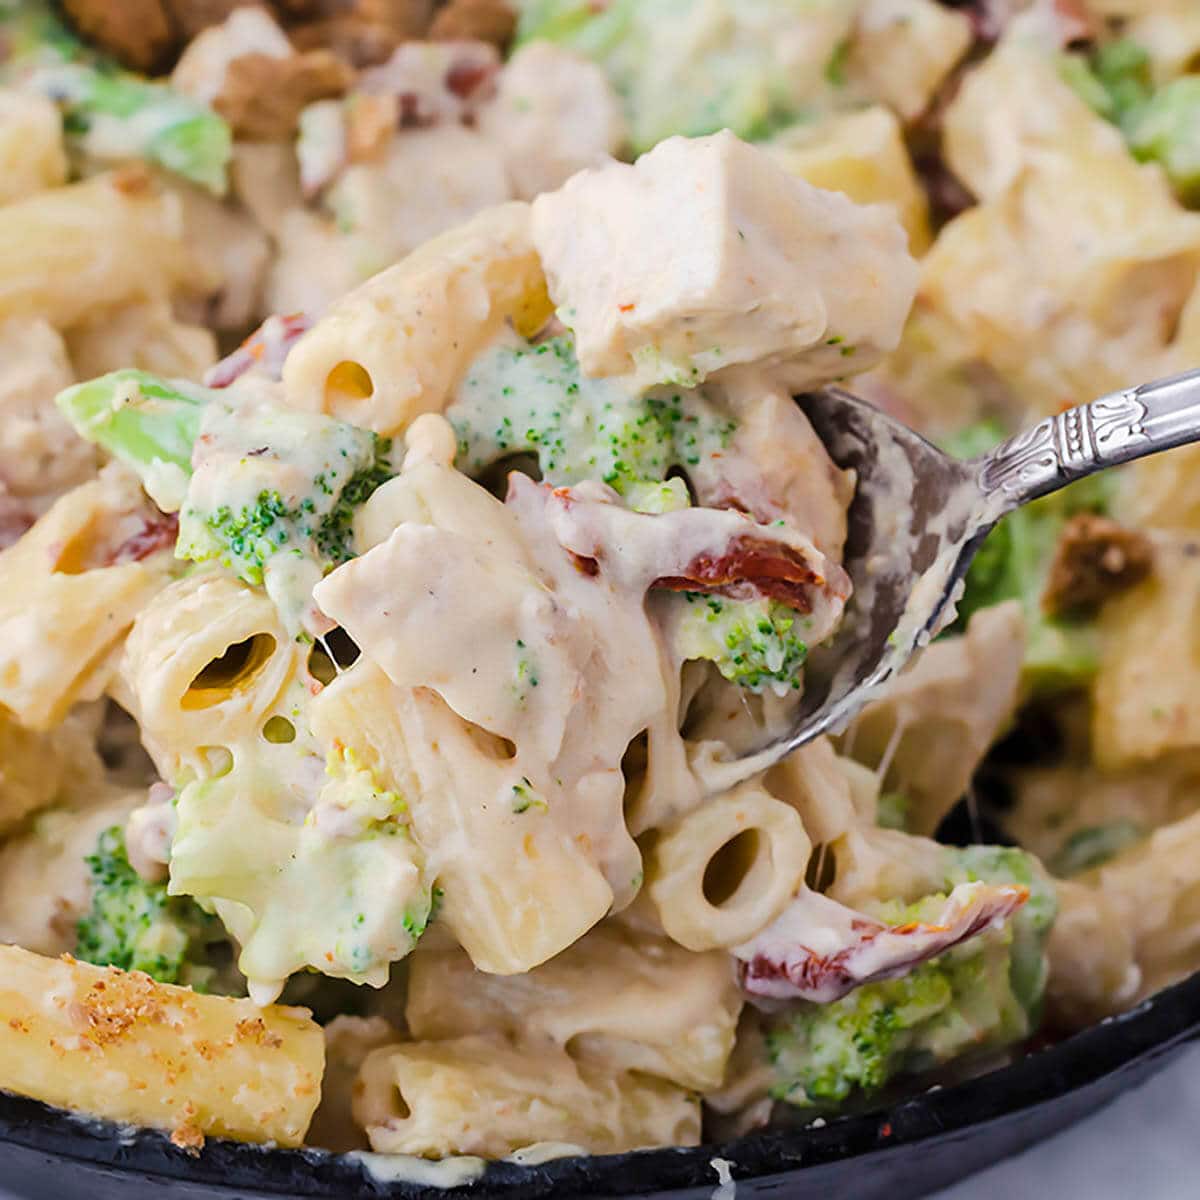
76 826 226 991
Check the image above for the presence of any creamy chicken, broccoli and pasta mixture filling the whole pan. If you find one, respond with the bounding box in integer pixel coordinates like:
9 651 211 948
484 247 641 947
0 0 1200 1159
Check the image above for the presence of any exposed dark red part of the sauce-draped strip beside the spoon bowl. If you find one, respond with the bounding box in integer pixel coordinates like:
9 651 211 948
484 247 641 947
650 538 850 613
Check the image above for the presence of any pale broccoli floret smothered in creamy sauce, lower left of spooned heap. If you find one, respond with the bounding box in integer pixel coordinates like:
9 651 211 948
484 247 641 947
170 737 434 1003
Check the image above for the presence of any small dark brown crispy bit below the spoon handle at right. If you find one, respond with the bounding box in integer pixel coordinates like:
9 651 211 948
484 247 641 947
1042 512 1153 614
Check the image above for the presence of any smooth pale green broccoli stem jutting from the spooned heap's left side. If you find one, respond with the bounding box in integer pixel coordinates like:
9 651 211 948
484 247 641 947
55 368 210 494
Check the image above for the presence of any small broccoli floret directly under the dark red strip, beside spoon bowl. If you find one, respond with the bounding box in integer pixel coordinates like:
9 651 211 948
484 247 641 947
673 592 809 696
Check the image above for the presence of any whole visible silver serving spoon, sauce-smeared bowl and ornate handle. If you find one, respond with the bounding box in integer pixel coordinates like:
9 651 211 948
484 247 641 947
728 371 1200 778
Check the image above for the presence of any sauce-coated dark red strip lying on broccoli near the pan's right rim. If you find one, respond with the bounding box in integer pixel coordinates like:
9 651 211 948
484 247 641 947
733 883 1030 1004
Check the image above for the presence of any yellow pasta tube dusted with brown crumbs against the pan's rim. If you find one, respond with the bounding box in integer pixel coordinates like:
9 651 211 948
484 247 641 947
0 946 325 1147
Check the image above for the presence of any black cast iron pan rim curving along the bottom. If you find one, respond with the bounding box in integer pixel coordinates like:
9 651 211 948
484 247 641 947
0 973 1200 1200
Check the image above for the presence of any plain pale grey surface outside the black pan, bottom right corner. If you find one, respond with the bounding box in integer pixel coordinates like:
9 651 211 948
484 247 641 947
0 1046 1200 1200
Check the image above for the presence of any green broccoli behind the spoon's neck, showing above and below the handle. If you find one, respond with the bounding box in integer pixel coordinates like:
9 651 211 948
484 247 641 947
947 422 1112 692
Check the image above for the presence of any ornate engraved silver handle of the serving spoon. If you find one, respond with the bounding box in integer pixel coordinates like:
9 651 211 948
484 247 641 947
979 371 1200 512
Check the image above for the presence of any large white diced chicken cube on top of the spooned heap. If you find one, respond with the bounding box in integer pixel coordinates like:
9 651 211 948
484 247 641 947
533 132 917 389
